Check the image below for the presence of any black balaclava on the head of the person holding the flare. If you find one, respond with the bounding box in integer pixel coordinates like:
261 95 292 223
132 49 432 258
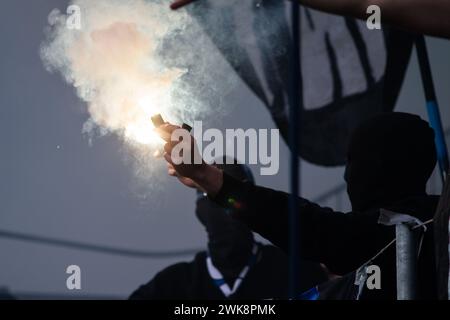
345 112 436 211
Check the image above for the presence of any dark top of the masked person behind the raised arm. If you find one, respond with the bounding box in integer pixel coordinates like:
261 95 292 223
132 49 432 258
130 246 324 300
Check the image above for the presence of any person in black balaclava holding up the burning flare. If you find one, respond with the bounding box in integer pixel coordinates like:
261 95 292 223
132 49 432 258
158 113 438 299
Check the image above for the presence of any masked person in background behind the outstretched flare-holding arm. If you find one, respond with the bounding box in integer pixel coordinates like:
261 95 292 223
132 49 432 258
130 162 326 300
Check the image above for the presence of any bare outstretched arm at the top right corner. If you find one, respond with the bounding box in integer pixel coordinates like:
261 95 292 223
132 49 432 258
299 0 450 38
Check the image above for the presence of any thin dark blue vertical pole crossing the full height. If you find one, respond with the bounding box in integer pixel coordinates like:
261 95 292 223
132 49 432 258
289 2 303 299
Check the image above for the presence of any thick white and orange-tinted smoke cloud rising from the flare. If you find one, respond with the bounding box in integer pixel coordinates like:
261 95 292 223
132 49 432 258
41 0 224 150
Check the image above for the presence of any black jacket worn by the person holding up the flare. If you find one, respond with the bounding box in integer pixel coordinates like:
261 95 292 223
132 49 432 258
214 174 438 299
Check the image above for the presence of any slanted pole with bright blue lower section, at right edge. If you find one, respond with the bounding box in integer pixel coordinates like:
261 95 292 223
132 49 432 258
416 35 449 181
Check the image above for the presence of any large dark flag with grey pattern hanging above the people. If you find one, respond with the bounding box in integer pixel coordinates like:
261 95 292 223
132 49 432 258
188 0 412 166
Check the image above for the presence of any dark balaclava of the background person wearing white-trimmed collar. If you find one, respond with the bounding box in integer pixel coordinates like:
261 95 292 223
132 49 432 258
196 159 254 282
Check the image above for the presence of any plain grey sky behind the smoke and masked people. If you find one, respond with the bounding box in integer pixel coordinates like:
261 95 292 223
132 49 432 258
0 0 450 297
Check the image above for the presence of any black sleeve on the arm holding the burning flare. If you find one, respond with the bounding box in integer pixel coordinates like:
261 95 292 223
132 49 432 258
213 173 394 274
